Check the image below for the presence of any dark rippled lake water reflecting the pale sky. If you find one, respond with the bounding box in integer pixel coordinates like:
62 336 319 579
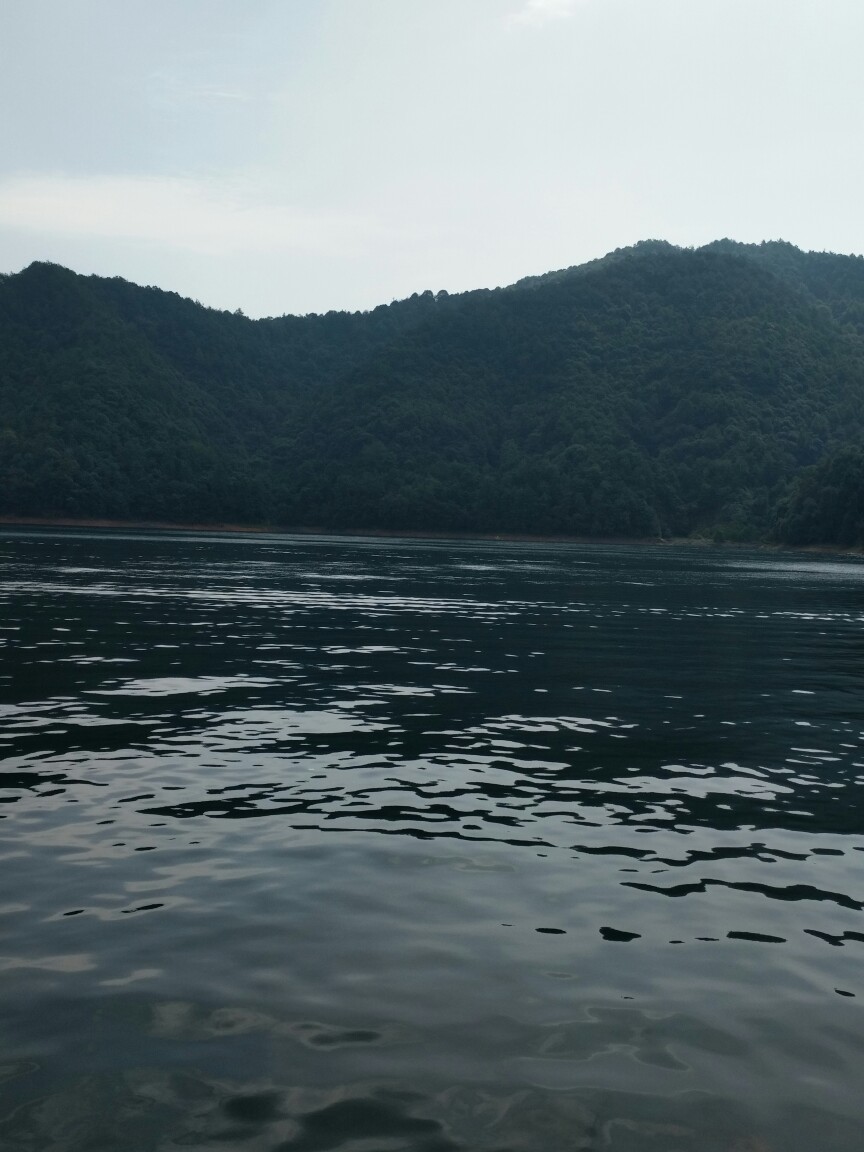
0 531 864 1152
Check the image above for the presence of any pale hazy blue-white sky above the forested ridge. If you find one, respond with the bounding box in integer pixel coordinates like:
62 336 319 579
0 0 864 317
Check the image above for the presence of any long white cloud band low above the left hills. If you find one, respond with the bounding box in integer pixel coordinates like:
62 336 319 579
0 174 384 256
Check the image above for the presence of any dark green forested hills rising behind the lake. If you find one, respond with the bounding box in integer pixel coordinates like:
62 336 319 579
0 241 864 544
